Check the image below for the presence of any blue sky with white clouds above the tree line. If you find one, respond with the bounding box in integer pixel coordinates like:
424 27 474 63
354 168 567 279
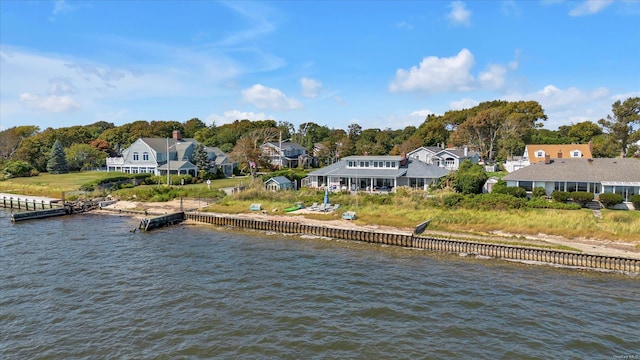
0 0 640 129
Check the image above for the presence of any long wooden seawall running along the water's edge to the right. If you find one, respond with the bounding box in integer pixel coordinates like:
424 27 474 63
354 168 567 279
186 213 640 273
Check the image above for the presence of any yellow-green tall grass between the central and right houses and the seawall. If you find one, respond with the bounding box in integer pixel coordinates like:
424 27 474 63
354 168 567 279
202 189 640 244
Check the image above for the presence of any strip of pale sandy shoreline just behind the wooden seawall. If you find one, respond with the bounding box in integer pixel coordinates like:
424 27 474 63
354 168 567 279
96 199 640 259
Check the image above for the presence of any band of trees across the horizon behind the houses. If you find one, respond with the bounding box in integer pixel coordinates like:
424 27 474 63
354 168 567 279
0 97 640 176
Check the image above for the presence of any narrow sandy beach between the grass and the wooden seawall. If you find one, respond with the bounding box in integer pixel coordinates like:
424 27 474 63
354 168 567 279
98 199 640 259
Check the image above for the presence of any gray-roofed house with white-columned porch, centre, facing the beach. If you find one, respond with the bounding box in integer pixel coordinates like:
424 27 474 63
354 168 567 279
302 155 449 192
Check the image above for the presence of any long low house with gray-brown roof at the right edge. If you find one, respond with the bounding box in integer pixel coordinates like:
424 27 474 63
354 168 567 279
502 158 640 202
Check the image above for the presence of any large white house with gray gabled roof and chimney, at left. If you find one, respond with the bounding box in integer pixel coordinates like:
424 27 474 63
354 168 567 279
107 130 234 176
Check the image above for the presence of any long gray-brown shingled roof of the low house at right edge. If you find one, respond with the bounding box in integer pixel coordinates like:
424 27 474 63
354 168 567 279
503 158 640 185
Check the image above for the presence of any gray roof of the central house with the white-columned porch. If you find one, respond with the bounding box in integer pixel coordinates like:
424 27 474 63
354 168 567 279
309 156 449 179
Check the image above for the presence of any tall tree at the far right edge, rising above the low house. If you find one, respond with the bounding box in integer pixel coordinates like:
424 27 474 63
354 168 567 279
598 97 640 156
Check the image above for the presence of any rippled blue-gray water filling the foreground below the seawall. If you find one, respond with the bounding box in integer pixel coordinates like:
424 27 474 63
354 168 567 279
0 211 640 359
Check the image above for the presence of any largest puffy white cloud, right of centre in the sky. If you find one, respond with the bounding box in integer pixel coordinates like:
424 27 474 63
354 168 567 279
389 49 475 92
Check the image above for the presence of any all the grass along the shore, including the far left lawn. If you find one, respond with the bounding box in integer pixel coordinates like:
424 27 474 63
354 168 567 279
5 172 640 246
